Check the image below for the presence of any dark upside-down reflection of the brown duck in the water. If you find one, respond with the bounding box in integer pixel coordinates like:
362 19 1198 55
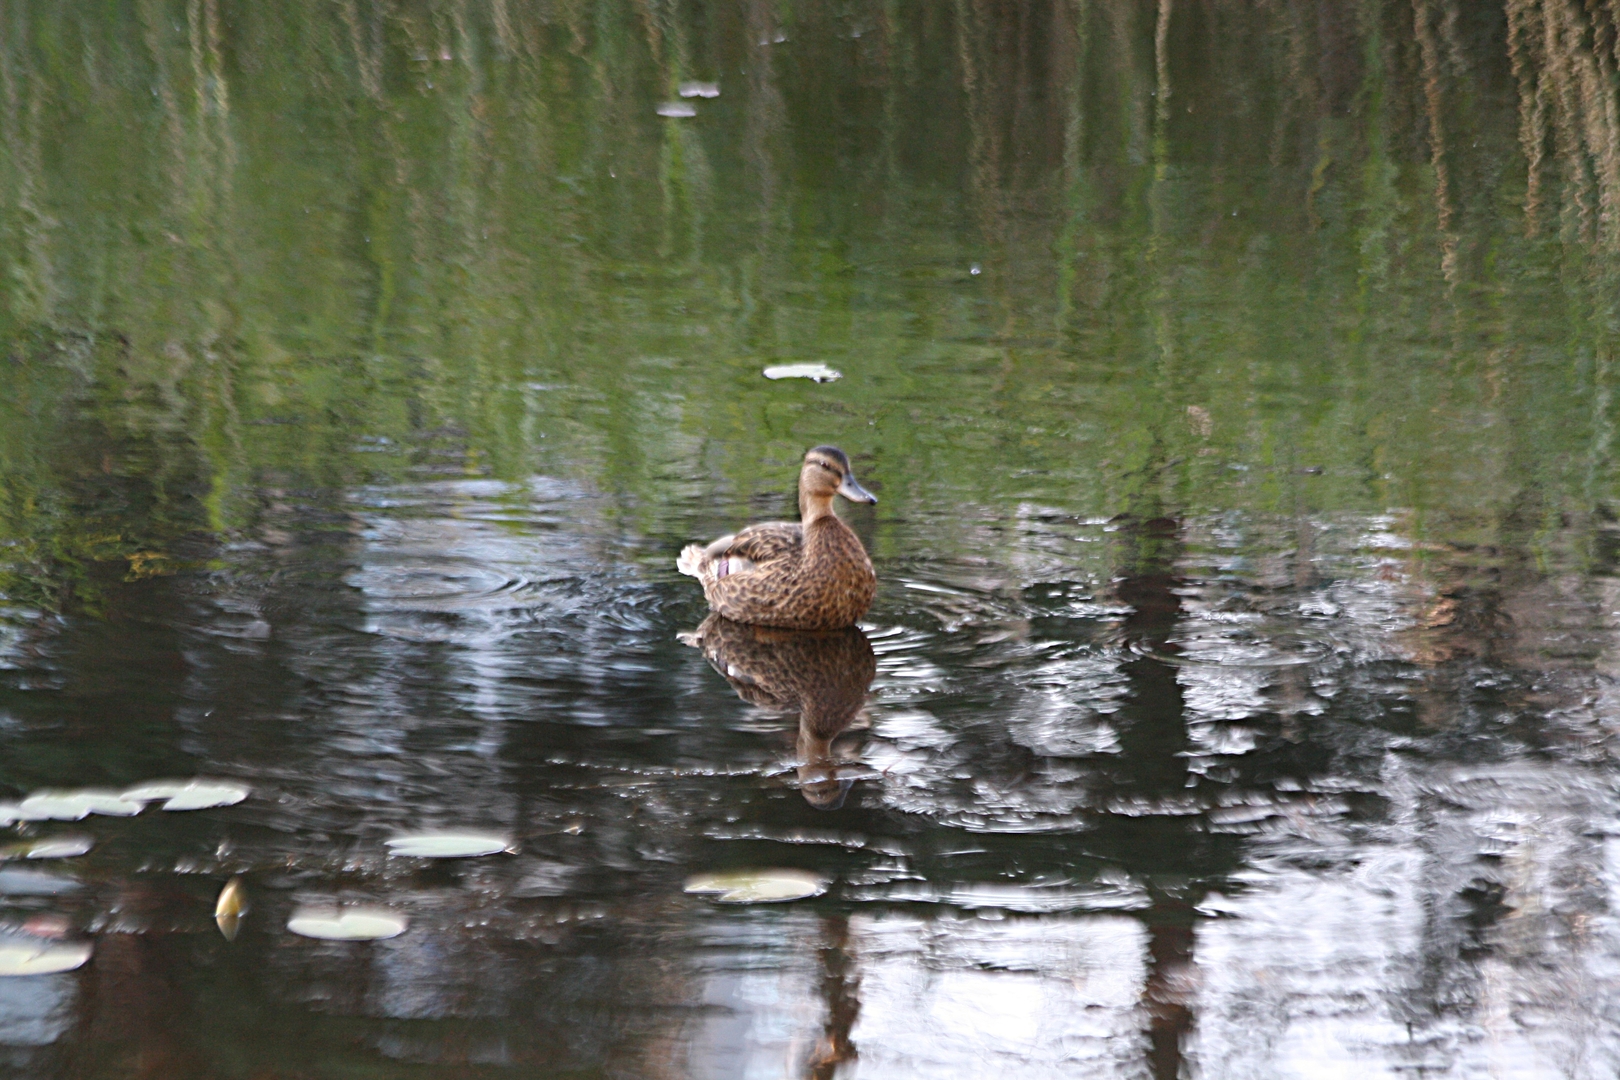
680 615 878 810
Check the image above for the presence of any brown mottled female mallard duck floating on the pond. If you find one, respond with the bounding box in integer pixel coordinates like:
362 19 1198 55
676 447 878 630
